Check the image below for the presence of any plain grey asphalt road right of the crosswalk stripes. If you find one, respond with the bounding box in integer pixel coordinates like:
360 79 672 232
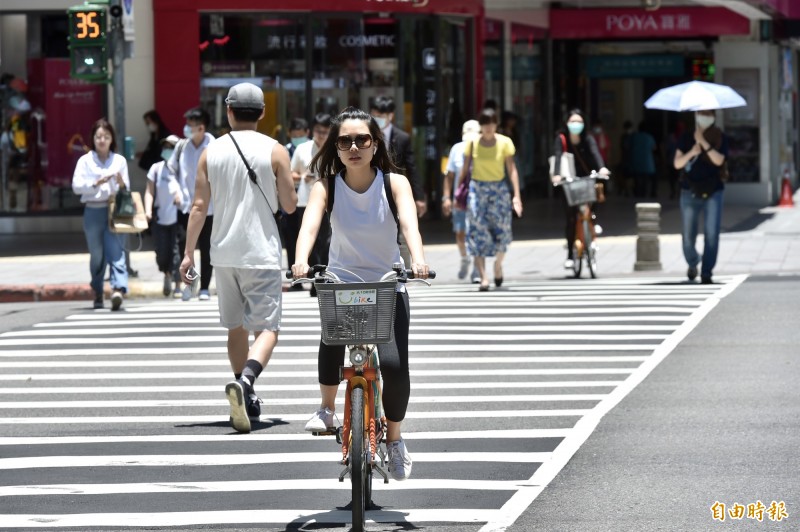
509 277 800 532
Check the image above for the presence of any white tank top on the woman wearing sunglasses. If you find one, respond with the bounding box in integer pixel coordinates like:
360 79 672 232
326 170 402 282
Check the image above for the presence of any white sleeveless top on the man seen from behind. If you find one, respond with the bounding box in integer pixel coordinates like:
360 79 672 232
206 130 281 270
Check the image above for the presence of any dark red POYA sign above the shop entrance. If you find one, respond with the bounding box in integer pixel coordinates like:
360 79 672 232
550 7 750 39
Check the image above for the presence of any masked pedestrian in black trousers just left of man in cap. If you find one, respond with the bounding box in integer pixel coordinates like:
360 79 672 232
167 107 214 301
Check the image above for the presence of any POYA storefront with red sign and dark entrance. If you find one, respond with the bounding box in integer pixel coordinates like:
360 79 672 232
550 7 761 193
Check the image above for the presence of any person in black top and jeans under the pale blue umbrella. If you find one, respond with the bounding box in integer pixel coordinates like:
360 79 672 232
673 111 728 284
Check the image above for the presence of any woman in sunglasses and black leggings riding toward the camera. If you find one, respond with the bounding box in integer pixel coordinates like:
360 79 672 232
292 107 428 480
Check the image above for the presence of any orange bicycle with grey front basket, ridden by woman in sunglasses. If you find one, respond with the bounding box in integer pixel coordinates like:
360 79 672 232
286 264 436 532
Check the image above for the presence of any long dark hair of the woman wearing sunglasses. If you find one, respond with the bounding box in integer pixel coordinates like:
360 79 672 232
309 107 398 178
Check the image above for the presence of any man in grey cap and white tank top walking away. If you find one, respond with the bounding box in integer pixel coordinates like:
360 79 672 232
181 83 297 432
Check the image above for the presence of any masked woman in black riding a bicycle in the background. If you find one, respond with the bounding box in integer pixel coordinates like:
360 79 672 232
553 109 610 270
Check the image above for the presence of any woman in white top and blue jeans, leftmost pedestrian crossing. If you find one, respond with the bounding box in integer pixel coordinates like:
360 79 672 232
72 118 130 310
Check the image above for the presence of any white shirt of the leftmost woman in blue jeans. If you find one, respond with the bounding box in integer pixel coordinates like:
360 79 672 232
72 150 131 207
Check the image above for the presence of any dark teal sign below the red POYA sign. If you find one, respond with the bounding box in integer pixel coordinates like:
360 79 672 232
586 54 685 78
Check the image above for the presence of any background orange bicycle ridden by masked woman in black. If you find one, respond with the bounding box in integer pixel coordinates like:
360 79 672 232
553 170 608 279
